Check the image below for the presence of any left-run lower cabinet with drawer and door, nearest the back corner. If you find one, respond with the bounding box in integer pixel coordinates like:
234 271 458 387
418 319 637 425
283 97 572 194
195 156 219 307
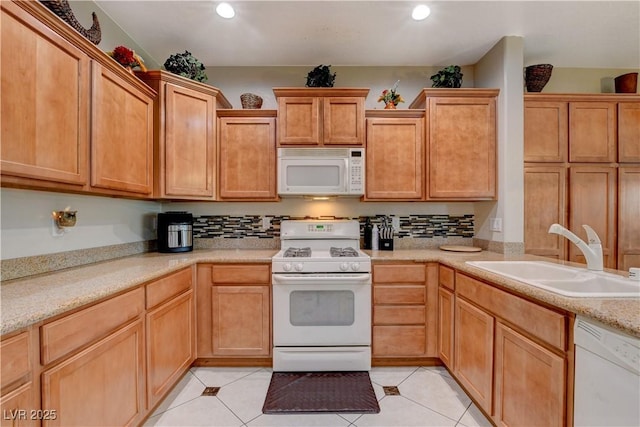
146 268 196 409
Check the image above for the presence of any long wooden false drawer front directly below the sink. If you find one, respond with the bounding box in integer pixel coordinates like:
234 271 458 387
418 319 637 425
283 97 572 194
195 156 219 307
456 273 567 350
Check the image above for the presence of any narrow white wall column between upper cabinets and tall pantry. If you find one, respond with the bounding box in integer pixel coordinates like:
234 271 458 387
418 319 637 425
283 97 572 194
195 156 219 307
475 36 524 246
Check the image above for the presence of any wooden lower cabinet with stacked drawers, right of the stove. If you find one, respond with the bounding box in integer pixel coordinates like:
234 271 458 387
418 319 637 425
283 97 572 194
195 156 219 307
372 263 437 361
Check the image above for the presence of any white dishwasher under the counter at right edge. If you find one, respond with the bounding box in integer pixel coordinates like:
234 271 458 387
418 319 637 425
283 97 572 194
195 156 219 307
574 316 640 427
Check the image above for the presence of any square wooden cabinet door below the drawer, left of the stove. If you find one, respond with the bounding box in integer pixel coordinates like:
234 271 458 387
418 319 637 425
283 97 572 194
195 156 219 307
211 286 271 356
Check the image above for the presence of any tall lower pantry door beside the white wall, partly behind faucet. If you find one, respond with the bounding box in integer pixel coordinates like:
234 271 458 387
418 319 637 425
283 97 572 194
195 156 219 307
524 166 567 260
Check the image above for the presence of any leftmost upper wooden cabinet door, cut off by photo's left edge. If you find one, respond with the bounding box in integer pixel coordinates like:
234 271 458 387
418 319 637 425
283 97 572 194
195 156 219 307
0 1 89 188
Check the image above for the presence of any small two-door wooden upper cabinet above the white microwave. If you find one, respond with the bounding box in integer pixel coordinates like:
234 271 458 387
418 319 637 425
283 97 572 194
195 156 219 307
273 88 369 147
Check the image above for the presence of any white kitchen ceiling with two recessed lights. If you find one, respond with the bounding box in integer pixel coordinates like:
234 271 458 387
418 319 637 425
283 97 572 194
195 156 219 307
95 0 640 68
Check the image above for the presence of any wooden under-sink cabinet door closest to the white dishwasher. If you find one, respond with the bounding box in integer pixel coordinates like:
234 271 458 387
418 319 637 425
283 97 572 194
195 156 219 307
495 322 566 427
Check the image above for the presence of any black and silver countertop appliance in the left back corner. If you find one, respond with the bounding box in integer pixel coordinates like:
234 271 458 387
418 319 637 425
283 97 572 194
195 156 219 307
158 211 193 252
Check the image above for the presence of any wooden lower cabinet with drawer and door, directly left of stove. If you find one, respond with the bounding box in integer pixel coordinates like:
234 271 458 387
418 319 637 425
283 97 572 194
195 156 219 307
197 264 271 365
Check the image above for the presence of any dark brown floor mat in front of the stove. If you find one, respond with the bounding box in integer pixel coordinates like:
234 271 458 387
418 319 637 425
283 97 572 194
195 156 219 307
262 372 380 414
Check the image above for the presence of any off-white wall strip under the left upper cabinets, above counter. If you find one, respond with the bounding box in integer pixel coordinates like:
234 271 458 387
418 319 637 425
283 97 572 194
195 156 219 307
0 188 161 259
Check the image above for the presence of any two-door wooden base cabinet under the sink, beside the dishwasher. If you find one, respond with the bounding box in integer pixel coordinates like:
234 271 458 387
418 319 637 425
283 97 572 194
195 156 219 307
453 272 573 426
